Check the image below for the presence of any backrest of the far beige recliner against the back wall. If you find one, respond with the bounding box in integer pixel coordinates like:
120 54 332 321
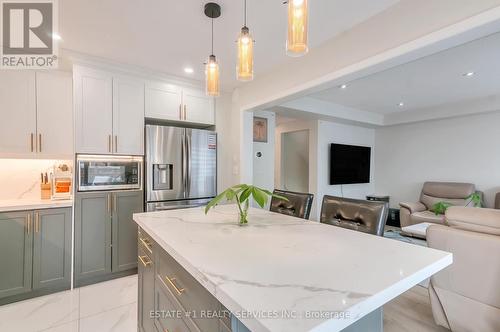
420 182 475 211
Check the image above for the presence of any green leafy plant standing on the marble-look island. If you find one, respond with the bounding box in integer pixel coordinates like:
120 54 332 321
205 184 288 225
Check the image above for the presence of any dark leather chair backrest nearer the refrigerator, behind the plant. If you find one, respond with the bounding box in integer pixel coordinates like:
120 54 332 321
270 189 314 219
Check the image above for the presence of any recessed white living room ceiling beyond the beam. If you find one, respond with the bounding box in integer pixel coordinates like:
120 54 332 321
309 33 500 115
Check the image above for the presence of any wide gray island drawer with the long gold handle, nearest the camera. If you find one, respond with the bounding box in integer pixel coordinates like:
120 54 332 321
157 250 220 331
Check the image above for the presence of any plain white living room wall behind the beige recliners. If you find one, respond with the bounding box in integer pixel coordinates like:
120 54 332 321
375 112 500 207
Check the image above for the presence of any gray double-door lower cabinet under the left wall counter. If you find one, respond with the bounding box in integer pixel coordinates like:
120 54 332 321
0 208 71 304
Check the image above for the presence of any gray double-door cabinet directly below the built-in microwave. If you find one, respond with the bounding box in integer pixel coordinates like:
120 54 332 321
75 191 144 286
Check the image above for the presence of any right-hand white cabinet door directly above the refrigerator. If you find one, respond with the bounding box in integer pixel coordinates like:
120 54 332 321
182 89 215 125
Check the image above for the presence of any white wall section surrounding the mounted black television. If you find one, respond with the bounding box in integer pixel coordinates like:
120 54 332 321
316 120 376 219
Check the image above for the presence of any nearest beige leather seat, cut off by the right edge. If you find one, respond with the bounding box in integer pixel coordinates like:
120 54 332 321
427 207 500 332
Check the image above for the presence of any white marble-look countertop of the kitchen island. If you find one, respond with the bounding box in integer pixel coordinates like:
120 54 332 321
134 205 452 332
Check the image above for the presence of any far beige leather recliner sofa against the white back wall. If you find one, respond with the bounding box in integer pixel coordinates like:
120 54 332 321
399 182 476 227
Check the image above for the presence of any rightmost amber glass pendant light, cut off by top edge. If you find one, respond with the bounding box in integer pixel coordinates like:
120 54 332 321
286 0 309 56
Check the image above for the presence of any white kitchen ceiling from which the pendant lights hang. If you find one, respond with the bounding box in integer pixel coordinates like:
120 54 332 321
59 0 399 89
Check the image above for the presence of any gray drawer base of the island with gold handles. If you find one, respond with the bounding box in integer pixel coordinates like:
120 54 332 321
138 229 241 332
